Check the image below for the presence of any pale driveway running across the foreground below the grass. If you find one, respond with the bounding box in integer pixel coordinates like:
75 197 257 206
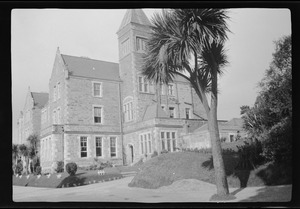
13 176 292 203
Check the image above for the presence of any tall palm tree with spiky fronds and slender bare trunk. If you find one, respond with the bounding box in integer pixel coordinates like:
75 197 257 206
142 9 229 196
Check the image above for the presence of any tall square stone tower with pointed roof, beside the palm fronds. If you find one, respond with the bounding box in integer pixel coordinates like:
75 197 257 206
117 9 155 126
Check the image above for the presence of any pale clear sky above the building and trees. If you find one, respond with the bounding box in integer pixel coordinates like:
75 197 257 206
11 8 291 141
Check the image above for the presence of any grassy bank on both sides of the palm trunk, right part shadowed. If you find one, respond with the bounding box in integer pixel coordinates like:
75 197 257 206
129 142 292 189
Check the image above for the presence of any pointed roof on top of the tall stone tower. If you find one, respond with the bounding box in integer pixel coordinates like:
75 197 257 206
118 9 151 31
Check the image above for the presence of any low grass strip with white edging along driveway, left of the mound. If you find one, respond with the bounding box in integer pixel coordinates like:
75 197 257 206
13 168 123 188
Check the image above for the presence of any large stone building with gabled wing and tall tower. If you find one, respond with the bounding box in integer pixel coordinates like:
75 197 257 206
20 9 245 172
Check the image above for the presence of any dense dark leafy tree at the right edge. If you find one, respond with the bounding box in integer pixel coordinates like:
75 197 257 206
241 35 292 164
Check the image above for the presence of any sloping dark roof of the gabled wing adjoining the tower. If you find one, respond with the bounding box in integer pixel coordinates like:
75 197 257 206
61 54 120 81
